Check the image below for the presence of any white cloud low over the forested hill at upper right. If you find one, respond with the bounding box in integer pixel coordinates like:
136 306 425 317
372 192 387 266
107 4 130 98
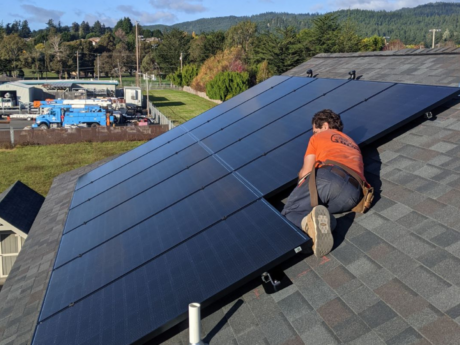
329 0 454 11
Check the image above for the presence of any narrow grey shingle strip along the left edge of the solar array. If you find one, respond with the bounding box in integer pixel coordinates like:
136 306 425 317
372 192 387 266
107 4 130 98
0 158 117 345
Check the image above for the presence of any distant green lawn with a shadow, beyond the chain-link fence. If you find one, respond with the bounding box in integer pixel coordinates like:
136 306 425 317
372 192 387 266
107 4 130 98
149 89 216 124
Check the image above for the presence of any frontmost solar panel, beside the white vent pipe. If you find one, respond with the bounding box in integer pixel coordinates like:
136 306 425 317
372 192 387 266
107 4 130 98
33 200 305 345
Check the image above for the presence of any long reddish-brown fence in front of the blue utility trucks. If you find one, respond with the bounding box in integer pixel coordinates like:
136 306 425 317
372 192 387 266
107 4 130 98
0 125 169 147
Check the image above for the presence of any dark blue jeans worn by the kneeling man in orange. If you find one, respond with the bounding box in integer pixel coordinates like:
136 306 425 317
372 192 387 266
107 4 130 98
281 166 362 228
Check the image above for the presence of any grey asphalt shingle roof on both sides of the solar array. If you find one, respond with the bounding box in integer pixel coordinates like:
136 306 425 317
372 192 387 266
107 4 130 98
0 52 460 345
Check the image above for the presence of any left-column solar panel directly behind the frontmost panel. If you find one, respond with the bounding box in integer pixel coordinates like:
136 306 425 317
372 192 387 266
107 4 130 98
41 175 257 318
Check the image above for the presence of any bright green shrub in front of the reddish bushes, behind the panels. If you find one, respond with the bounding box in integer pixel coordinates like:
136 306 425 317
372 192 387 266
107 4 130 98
206 72 249 101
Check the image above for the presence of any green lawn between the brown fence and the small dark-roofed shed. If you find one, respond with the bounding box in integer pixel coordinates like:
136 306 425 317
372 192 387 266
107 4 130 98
0 141 144 196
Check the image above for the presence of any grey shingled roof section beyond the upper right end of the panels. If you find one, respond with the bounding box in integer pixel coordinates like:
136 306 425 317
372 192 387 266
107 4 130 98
284 48 460 86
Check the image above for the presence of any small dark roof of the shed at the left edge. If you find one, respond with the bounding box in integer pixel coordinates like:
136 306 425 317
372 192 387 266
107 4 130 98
0 181 45 234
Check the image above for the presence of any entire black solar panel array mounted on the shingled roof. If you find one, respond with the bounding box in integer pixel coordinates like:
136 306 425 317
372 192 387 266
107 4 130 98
33 77 458 344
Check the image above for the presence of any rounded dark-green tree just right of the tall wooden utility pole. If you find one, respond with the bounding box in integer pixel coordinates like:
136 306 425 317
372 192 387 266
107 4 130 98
157 28 191 74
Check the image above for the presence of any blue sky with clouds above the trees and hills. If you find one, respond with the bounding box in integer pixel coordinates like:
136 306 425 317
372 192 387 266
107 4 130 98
0 0 460 30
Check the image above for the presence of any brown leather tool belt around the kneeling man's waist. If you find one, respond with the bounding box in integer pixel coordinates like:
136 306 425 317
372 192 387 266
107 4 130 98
308 160 374 213
